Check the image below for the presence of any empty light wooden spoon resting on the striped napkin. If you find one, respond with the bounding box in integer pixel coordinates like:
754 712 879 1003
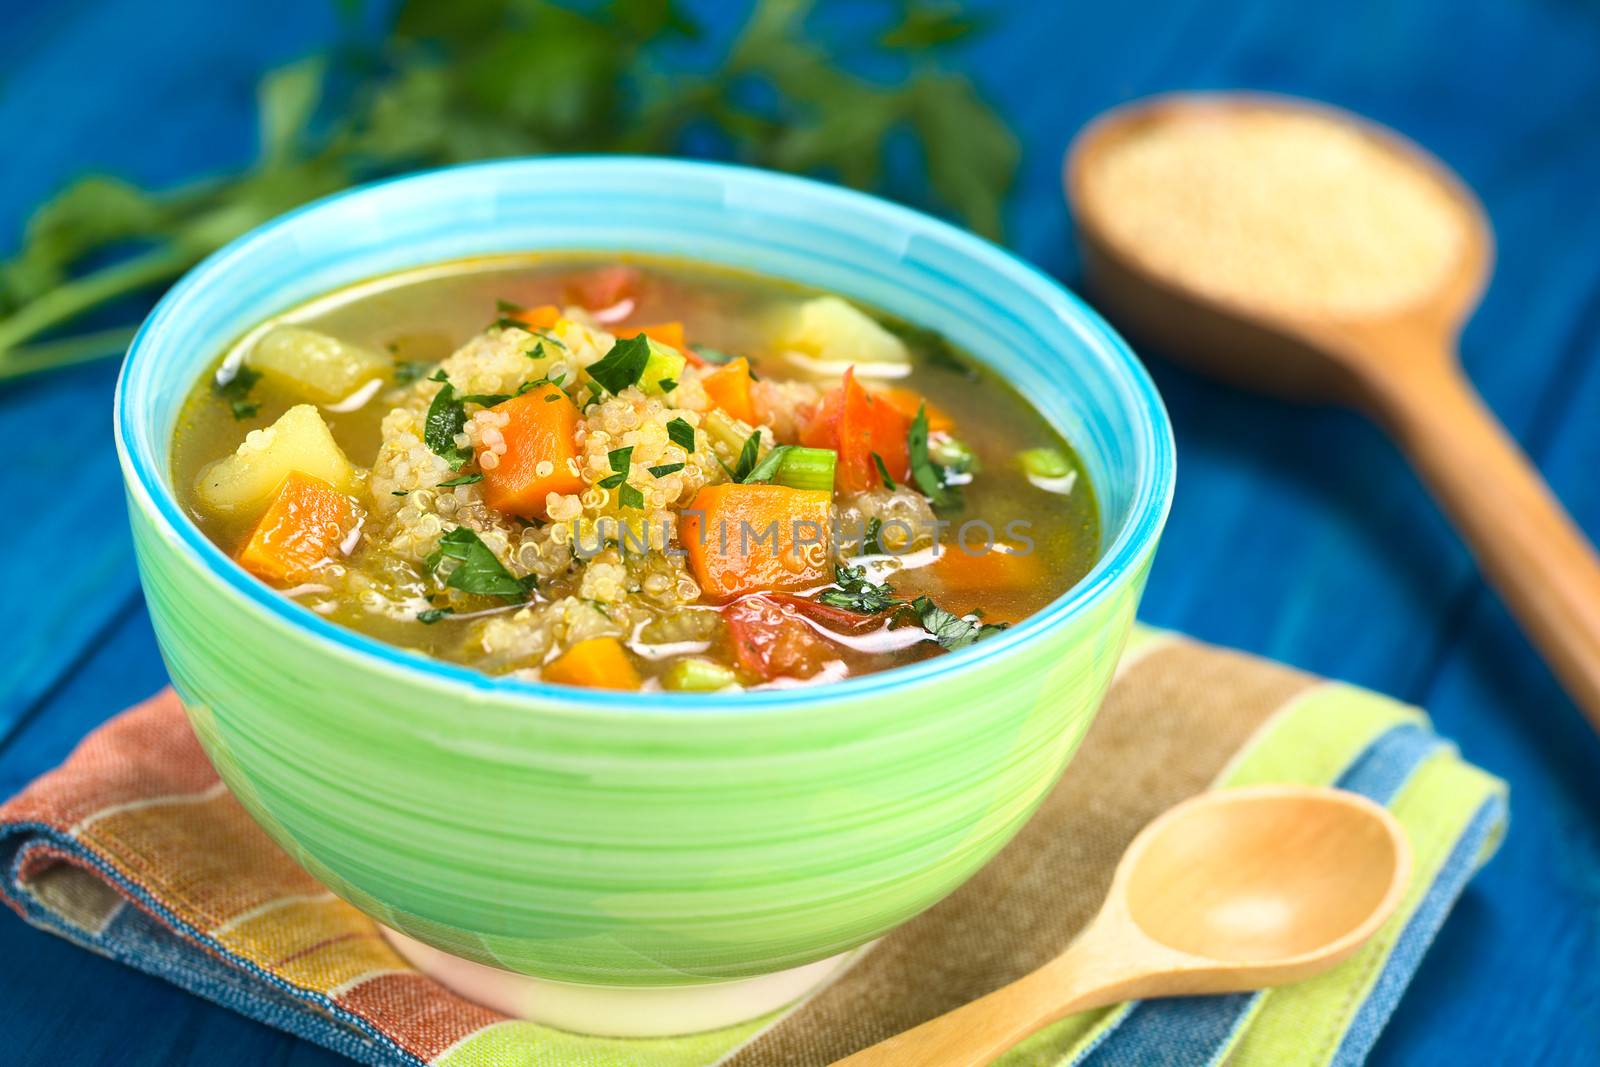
838 785 1411 1067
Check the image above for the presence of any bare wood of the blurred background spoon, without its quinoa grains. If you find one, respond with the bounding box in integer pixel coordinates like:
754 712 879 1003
1066 93 1600 729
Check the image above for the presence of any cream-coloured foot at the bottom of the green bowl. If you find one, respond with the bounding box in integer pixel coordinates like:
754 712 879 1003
381 926 875 1037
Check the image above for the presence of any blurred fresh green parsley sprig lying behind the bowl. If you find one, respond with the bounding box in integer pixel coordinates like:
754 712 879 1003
0 0 1018 379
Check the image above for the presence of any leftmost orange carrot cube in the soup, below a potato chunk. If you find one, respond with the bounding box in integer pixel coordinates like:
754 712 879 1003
238 470 362 582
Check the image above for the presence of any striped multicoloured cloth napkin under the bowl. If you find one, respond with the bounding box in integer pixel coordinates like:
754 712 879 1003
0 630 1506 1067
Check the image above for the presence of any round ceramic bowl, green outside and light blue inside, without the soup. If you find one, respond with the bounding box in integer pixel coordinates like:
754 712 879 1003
115 158 1173 1004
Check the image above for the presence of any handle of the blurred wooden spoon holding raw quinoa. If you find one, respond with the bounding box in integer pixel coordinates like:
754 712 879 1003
1366 350 1600 731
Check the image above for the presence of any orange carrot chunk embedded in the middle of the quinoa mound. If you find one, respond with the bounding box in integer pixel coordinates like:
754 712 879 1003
480 382 584 518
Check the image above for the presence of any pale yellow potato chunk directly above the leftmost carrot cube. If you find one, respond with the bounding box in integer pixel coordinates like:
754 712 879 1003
195 403 357 517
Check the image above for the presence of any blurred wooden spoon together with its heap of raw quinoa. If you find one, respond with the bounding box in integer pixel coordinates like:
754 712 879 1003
1066 93 1600 729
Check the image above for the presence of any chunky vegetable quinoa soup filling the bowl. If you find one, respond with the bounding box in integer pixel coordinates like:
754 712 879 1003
173 256 1101 691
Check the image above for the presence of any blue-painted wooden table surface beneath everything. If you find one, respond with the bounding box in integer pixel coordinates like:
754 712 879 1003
0 0 1600 1067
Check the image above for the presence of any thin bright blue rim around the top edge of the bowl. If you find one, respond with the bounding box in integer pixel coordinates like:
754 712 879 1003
112 155 1176 713
